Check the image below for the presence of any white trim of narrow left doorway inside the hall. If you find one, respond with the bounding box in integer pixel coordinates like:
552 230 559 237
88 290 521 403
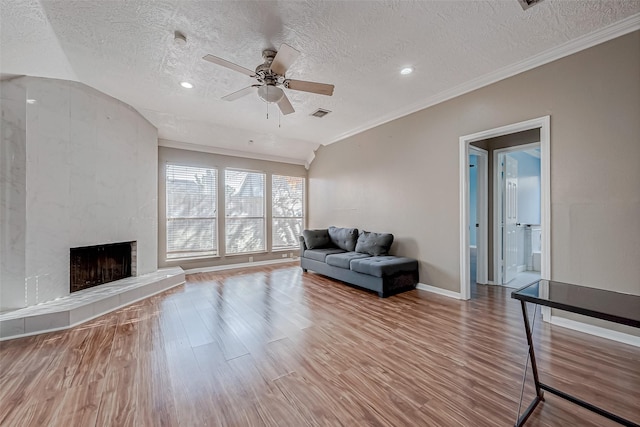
466 146 489 284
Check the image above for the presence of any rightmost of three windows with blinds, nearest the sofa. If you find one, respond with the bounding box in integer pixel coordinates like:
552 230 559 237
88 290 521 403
271 175 304 250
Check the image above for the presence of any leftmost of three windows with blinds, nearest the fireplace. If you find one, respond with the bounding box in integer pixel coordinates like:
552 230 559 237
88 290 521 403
166 164 218 259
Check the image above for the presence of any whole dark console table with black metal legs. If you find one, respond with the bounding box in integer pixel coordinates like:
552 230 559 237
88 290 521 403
511 280 640 427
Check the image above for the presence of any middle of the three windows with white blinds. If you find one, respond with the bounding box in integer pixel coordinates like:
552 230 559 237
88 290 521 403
225 169 266 254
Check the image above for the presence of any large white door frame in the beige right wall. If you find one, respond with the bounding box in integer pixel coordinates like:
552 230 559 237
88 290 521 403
458 116 551 300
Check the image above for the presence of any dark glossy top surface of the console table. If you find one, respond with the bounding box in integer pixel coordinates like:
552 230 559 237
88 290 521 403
511 280 640 328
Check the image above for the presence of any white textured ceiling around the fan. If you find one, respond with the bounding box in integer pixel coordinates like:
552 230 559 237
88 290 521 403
0 0 640 162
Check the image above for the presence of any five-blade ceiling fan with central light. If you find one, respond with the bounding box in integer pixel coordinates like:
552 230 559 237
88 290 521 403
202 43 334 115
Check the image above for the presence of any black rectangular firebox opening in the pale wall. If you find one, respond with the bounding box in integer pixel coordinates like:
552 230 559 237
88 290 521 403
70 242 137 292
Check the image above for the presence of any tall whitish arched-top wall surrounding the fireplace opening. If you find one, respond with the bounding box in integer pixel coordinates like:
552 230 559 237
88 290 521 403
0 77 158 310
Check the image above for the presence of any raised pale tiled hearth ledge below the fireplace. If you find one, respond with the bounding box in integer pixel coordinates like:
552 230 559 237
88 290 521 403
0 267 185 341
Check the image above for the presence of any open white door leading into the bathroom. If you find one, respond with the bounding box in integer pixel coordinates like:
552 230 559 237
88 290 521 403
502 154 518 284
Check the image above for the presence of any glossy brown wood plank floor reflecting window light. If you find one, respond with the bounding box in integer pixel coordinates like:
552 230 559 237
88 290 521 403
0 265 640 427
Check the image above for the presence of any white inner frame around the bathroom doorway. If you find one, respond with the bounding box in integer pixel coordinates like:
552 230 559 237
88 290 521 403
491 142 542 285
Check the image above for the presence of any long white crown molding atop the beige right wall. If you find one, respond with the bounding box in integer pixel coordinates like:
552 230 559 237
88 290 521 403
322 13 640 145
